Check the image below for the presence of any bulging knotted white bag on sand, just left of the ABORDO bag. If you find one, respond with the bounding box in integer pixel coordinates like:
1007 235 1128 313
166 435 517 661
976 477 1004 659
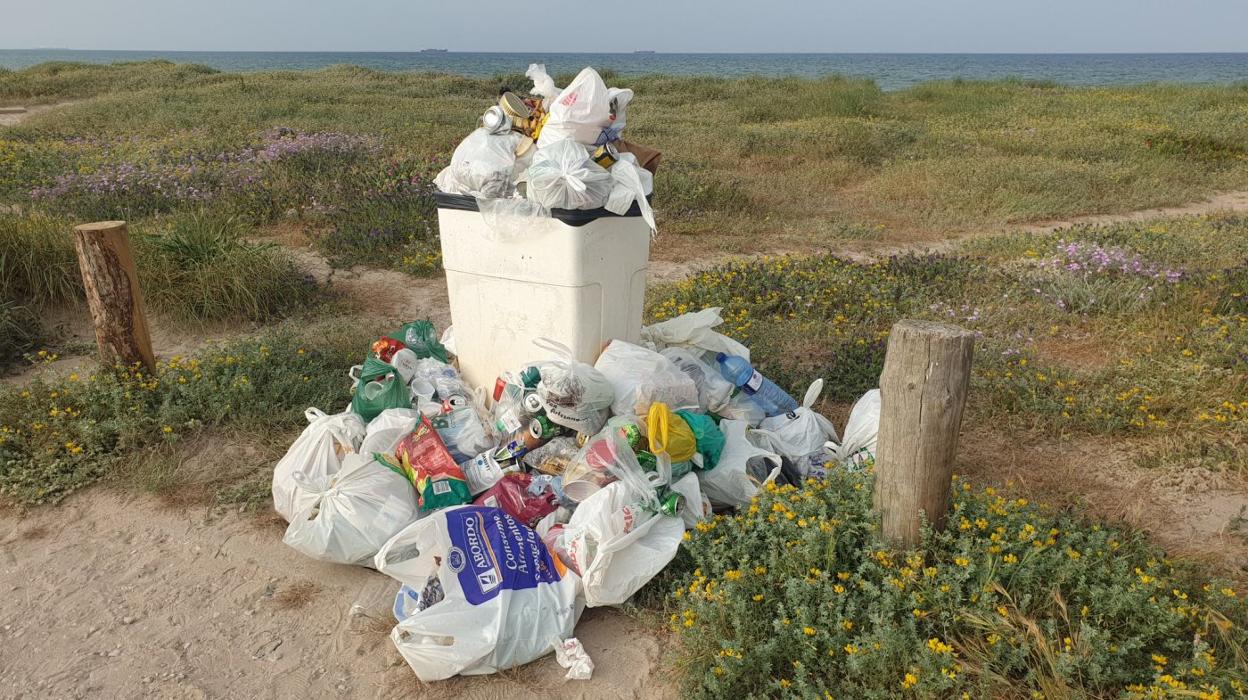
282 454 417 565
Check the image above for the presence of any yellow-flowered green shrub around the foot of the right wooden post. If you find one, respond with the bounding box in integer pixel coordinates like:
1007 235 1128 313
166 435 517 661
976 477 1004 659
670 470 1248 698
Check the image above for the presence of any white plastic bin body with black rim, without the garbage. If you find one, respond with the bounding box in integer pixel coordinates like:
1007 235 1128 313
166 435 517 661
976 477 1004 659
436 192 650 392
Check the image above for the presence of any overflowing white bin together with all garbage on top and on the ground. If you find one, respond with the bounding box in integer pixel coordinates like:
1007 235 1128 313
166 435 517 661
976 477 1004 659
272 66 879 681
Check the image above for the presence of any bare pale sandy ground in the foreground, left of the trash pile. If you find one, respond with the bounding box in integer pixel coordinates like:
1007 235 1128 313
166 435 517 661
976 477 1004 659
0 488 673 700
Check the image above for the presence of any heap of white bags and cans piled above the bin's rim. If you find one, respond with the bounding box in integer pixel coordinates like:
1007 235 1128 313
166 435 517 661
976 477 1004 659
434 64 661 231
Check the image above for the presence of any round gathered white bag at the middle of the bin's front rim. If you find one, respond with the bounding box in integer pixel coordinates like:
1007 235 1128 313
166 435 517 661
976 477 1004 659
525 137 615 210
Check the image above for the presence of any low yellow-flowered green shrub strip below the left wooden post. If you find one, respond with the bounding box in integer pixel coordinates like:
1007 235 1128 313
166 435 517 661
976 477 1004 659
0 324 371 504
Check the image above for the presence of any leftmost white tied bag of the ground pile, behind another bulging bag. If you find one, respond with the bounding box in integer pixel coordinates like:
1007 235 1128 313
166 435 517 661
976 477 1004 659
273 408 366 522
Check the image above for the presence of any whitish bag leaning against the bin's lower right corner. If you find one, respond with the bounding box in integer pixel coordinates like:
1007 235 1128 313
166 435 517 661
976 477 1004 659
594 338 698 416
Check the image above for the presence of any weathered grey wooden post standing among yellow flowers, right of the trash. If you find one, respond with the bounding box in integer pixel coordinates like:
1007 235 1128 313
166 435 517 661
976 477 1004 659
875 319 975 548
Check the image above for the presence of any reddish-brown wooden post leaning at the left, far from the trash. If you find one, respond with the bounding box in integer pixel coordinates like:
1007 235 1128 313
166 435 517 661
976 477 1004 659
74 221 156 372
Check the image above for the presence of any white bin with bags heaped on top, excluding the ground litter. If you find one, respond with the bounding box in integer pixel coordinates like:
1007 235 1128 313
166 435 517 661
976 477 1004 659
434 65 661 384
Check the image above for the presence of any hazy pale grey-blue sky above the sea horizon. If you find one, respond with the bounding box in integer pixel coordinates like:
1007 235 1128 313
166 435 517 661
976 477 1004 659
0 0 1248 52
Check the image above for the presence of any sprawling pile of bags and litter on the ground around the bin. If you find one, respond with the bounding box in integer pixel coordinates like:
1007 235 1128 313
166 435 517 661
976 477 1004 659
273 308 880 681
